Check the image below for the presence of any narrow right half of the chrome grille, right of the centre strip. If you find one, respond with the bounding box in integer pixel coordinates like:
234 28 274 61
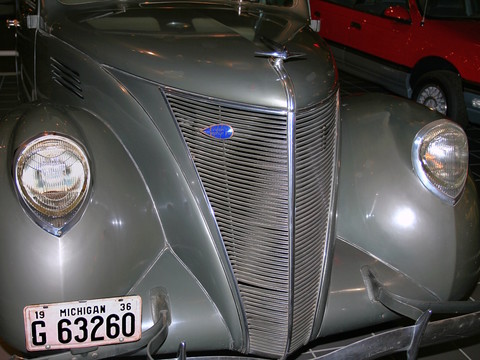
290 96 337 350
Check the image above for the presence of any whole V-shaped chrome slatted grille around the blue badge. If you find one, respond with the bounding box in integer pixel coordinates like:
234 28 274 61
164 89 336 356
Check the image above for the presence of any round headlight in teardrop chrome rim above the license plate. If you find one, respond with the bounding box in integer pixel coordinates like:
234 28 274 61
14 134 90 236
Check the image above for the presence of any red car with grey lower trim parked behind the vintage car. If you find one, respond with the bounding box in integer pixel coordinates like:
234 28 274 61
310 0 480 126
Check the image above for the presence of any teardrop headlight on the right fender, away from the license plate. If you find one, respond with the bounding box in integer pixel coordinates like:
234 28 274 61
412 120 468 205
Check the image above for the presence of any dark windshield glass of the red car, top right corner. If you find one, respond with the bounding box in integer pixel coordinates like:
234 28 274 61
418 0 480 19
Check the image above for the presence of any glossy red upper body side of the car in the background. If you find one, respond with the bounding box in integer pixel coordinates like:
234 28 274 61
311 0 480 83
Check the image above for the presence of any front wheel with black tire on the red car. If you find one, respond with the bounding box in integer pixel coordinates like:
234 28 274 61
412 70 468 128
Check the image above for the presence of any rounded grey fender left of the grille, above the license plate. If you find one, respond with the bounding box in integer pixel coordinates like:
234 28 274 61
0 104 165 349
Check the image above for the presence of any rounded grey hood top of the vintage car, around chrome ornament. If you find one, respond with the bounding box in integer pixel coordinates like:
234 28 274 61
50 3 337 108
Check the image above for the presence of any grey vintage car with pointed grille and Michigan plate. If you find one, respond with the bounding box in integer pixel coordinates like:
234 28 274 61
0 0 480 359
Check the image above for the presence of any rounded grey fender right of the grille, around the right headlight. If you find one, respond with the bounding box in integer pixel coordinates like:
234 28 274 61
336 94 480 299
